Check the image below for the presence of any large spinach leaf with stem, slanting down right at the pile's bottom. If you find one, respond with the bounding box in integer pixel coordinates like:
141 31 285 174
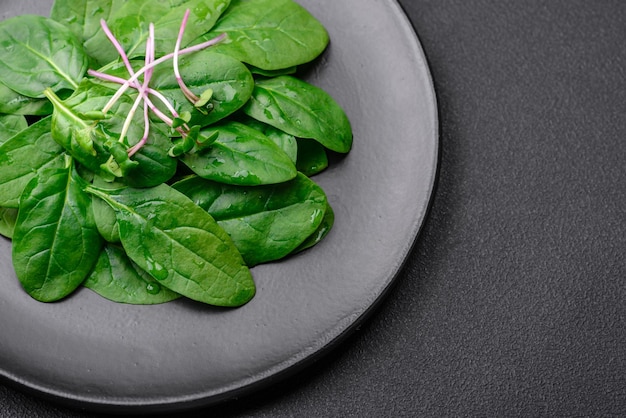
87 184 255 306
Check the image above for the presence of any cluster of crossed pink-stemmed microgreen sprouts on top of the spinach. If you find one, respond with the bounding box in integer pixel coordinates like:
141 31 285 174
89 9 225 162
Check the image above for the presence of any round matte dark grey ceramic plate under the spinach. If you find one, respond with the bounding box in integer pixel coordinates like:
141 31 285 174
0 0 438 412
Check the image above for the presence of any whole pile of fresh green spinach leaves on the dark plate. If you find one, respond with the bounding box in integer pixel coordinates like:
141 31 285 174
0 0 352 306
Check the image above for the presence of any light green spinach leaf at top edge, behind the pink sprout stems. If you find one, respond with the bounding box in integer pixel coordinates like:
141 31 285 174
72 0 230 65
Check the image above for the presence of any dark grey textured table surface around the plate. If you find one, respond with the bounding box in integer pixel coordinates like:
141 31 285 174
0 0 626 418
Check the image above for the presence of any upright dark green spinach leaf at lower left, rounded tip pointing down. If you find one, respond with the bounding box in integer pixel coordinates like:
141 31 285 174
12 164 101 302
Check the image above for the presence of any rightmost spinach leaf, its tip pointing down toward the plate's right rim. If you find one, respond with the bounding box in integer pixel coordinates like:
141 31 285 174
243 76 352 153
